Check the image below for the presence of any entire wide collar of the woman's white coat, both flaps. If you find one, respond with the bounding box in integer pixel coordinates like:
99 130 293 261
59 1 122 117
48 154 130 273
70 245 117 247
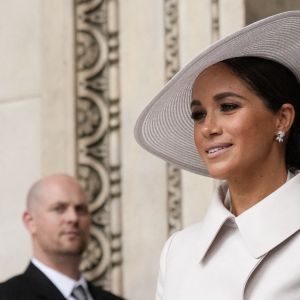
199 174 300 260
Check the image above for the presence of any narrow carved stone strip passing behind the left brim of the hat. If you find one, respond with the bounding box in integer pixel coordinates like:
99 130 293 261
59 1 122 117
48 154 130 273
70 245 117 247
164 0 182 235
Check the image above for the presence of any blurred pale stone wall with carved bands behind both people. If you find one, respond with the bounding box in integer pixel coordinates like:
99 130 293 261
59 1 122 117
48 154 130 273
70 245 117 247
0 0 300 300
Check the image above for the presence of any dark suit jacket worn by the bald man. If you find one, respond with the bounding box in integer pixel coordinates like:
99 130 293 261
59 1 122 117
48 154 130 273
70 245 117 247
0 263 123 300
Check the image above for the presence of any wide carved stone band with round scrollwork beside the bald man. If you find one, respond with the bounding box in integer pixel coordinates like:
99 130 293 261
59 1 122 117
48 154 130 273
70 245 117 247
74 0 122 294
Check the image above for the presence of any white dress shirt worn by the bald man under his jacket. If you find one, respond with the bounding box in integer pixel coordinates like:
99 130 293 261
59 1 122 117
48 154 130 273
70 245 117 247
31 258 93 300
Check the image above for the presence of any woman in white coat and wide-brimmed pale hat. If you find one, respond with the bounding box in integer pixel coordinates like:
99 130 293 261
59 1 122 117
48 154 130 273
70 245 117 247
135 11 300 300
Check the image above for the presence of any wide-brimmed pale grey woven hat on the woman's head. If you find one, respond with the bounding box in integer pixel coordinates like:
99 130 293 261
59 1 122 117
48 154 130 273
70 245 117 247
135 11 300 176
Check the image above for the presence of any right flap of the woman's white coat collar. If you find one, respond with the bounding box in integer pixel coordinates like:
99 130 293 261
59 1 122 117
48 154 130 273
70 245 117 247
235 174 300 258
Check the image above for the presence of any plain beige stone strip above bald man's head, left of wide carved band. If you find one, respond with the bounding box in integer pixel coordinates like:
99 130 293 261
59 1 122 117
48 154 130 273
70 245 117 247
39 0 76 175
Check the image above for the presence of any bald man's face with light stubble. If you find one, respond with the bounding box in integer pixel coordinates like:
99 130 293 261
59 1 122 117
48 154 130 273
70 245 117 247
27 176 90 256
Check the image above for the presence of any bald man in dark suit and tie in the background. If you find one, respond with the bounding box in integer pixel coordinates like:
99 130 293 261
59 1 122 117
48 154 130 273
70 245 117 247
0 174 122 300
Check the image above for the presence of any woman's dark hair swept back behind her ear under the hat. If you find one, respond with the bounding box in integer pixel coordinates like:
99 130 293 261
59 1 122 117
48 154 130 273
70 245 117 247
223 57 300 170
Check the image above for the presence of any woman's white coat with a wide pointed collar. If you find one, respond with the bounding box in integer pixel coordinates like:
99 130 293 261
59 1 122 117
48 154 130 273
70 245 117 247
156 174 300 300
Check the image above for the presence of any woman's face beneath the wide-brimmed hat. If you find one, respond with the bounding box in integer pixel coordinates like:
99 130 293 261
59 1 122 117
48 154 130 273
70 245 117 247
191 63 278 180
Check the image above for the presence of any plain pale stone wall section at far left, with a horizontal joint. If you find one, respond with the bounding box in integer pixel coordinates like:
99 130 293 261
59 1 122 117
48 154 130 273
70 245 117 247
0 0 41 281
